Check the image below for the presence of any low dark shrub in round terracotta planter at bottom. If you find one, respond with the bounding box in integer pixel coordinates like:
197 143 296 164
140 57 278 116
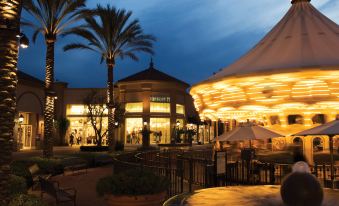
96 169 170 206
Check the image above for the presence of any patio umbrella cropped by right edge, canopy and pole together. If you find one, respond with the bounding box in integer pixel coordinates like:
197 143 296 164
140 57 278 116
293 119 339 186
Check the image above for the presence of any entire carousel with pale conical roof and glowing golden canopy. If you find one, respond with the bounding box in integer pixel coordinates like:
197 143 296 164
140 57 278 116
190 0 339 160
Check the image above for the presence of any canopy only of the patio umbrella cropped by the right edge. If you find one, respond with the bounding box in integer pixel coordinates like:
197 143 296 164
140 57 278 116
293 120 339 136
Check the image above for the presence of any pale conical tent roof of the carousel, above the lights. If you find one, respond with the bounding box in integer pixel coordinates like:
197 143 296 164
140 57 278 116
209 0 339 81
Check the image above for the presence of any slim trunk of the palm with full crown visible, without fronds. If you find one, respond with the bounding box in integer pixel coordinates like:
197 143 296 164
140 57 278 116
107 60 116 151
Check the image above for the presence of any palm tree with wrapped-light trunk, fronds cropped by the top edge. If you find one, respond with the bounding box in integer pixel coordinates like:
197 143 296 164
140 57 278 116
23 0 86 158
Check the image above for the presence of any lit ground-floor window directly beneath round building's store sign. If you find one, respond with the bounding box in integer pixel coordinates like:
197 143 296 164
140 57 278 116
150 118 171 144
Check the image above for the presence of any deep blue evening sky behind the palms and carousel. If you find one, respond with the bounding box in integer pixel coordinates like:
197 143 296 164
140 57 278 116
19 0 339 87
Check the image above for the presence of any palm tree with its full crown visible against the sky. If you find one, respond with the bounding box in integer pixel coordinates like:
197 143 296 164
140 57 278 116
64 5 155 150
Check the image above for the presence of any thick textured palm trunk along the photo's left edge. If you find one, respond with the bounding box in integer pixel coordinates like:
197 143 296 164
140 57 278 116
0 0 22 205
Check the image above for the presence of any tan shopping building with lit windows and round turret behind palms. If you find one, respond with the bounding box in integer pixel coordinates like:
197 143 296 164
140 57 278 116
14 62 208 149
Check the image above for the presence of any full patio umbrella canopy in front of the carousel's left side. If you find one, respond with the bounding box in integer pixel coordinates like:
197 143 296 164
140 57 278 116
218 126 284 142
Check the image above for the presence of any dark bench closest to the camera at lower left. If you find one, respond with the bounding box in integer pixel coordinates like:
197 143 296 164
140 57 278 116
39 177 77 206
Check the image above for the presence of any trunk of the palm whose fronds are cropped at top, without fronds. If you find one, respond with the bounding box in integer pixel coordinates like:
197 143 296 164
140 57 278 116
43 40 55 158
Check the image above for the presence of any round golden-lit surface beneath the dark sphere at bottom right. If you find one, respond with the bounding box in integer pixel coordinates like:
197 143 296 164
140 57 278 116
164 185 339 206
